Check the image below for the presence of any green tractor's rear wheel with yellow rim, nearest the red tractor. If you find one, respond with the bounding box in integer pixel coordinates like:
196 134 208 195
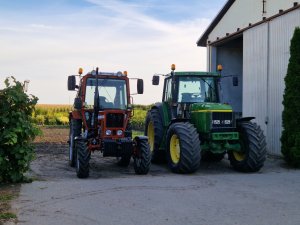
144 109 165 163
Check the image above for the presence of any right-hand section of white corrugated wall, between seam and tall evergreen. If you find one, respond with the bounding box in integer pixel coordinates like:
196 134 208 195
267 9 300 154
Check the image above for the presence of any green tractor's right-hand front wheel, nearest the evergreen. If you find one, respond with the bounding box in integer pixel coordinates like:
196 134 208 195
228 122 267 172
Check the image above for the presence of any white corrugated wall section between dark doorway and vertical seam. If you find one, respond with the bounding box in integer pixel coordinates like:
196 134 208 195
243 24 268 135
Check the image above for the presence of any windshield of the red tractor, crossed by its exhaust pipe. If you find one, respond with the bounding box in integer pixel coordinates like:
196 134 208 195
85 78 127 110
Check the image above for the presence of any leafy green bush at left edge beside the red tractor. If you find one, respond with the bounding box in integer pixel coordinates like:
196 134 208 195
0 77 39 183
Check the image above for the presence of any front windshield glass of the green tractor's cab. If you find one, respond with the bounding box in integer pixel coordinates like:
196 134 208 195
178 77 218 103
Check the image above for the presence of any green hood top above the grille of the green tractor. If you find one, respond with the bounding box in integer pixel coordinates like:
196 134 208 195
190 102 232 112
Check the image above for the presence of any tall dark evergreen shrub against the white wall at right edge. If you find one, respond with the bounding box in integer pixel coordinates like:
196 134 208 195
281 27 300 167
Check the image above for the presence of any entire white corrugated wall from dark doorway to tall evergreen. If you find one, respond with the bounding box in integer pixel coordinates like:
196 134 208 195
243 9 300 155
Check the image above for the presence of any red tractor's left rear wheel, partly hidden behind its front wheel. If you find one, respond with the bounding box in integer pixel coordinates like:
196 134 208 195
69 119 82 167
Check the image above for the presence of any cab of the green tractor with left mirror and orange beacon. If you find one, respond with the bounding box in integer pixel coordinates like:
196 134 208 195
152 64 221 119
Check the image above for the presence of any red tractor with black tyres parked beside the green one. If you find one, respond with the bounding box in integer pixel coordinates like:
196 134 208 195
68 68 151 178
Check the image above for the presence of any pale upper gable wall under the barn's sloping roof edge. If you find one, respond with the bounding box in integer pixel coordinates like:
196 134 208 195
208 0 300 42
